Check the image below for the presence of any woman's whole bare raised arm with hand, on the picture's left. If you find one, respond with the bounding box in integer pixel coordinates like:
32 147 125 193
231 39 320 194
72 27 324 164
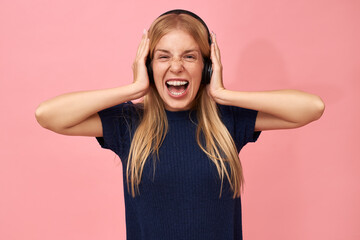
35 32 149 137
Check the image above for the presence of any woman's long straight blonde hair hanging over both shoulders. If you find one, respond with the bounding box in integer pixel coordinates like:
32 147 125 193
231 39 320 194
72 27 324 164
126 11 244 198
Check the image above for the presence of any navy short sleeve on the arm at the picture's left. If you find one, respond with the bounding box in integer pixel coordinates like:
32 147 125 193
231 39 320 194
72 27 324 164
96 102 139 158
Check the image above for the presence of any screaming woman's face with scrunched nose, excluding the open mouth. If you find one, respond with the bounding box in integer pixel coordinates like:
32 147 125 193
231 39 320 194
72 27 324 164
152 30 204 111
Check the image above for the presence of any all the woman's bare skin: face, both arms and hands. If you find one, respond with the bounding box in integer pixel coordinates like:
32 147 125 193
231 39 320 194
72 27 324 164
35 27 325 137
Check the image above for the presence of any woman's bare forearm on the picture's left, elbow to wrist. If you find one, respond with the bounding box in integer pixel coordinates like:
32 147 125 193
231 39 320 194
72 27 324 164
35 83 146 130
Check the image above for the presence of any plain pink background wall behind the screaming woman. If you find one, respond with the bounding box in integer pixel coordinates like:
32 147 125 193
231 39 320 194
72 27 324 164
0 0 360 240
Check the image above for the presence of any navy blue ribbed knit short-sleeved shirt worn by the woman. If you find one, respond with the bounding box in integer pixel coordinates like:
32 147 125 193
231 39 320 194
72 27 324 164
97 102 260 240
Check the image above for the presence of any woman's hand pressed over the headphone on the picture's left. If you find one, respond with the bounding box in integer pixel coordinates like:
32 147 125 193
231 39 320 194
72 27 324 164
132 29 150 95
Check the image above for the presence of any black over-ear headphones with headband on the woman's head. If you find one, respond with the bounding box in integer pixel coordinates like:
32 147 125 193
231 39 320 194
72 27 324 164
146 9 212 84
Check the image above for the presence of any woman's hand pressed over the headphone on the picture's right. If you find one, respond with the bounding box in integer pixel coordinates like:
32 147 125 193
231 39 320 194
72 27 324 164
207 32 225 102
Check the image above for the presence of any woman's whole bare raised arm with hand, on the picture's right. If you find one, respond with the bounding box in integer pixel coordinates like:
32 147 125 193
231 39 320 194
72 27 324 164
208 32 325 131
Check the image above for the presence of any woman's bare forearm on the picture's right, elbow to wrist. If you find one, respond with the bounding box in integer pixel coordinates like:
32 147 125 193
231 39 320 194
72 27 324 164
212 89 325 125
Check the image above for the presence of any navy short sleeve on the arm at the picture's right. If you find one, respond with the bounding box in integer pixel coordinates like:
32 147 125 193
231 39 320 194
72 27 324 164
219 105 261 151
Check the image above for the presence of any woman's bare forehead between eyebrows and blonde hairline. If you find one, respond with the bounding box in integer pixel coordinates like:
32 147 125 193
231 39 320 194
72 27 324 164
155 29 200 51
